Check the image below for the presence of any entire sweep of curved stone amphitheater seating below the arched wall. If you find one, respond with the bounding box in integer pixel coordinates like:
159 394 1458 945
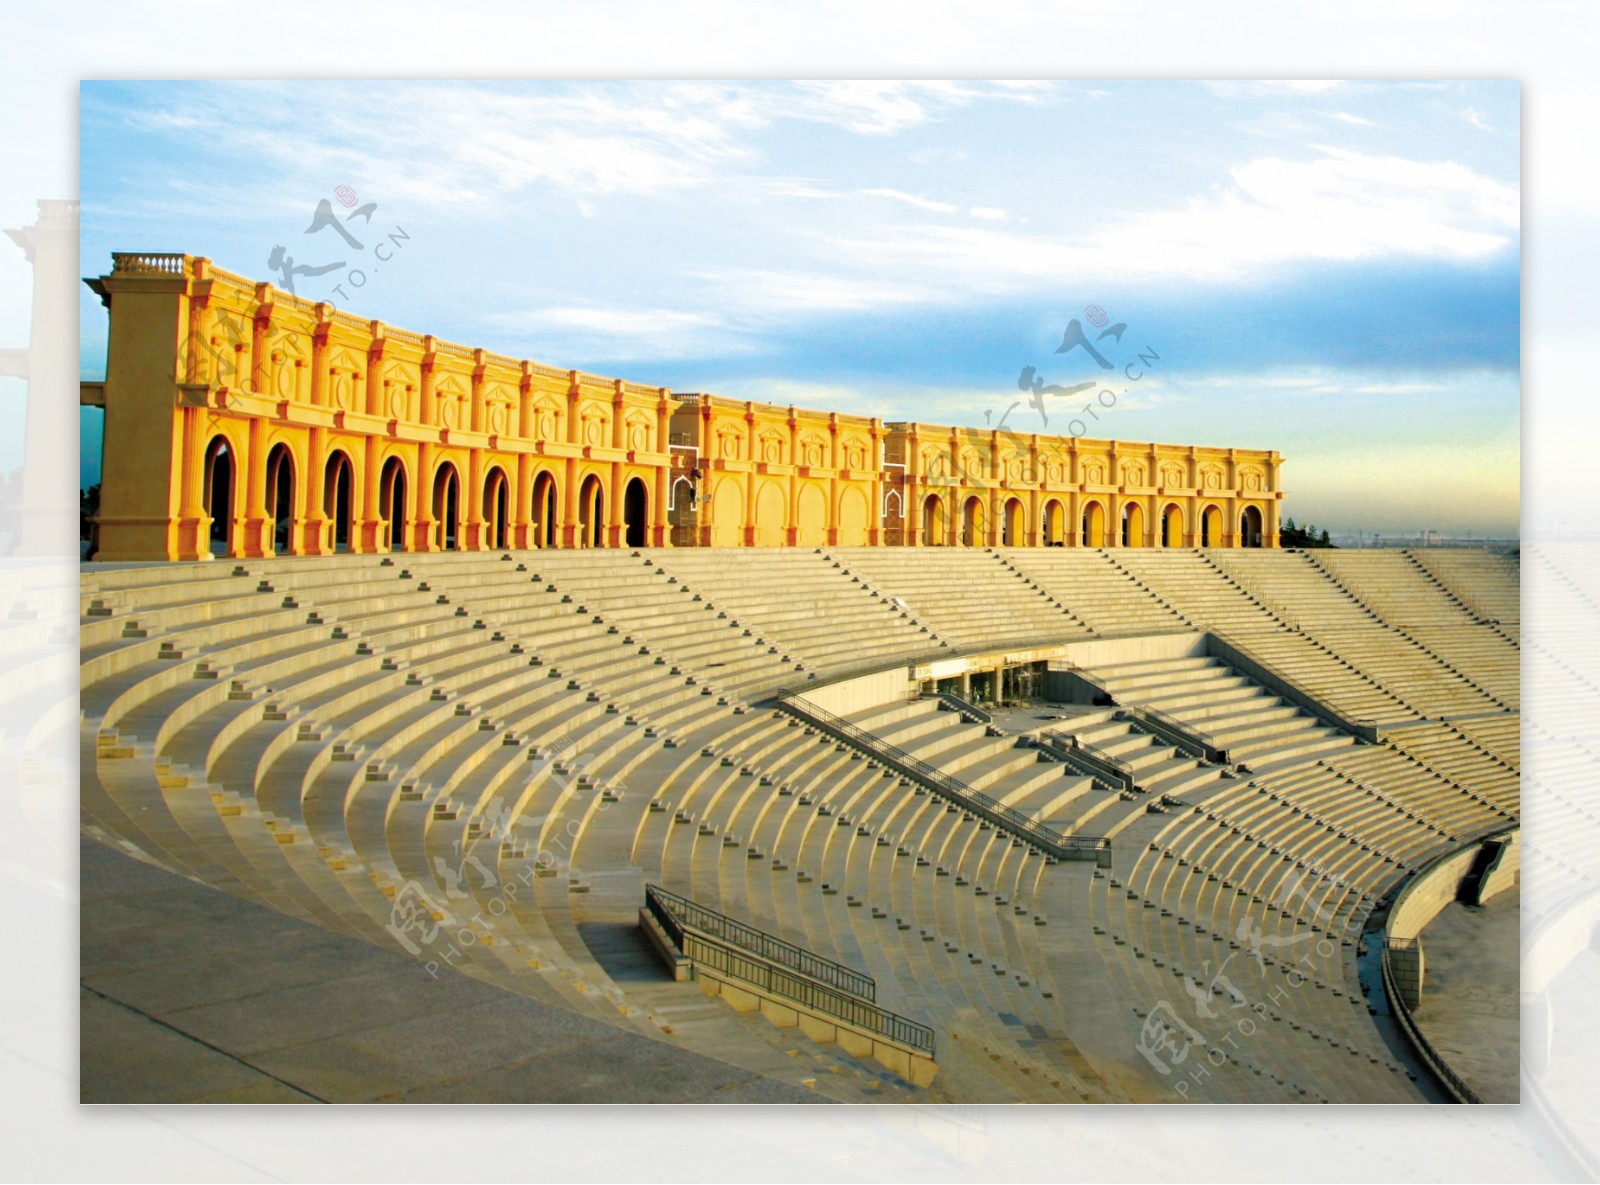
80 249 1520 1102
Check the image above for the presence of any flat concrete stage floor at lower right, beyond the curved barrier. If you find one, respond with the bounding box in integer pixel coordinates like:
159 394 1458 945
1414 884 1522 1103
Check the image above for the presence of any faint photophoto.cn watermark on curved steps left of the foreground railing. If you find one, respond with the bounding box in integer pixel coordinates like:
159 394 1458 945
384 737 622 979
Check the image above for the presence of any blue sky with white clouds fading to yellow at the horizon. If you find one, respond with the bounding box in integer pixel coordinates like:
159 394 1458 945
80 80 1520 536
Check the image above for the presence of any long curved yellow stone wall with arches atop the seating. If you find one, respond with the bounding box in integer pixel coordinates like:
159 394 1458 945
83 253 1282 561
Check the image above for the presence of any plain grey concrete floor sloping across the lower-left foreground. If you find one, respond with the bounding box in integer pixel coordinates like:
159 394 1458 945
78 838 827 1103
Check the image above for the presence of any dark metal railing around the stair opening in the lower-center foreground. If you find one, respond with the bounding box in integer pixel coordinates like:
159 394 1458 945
645 884 934 1057
